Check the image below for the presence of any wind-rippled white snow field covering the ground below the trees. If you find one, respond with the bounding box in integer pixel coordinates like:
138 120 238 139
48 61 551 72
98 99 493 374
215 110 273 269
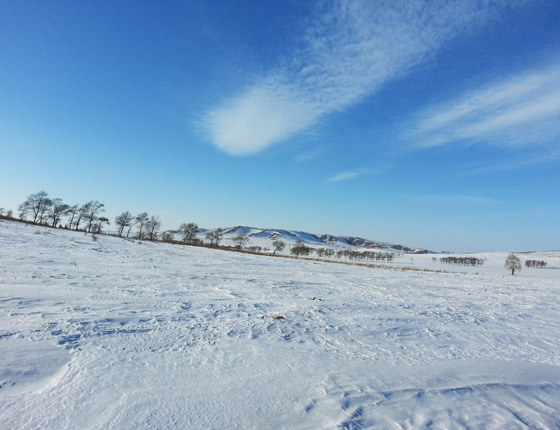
0 221 560 429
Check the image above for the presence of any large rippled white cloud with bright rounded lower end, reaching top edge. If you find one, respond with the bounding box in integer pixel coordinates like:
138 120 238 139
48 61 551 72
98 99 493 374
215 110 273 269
201 0 508 155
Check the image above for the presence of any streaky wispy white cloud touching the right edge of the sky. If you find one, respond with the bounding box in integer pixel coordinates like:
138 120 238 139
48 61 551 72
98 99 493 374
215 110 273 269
406 60 560 147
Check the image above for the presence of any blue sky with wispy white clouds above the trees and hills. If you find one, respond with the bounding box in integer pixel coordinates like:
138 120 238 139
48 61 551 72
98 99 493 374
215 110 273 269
0 0 560 252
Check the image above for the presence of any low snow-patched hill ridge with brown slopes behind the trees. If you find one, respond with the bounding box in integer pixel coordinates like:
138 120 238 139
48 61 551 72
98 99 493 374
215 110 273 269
198 226 431 254
